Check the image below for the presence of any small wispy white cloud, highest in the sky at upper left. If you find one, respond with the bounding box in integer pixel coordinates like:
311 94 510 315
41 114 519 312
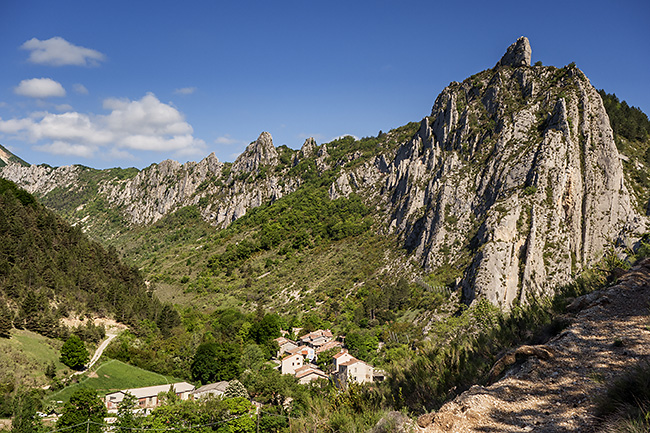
20 36 106 66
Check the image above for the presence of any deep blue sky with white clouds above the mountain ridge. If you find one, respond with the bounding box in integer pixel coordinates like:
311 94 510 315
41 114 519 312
0 0 650 168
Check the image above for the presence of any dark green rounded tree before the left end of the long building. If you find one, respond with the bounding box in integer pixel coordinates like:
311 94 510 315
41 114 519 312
56 388 108 433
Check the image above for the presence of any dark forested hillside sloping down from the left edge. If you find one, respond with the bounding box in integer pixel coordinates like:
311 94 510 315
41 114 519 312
0 179 172 337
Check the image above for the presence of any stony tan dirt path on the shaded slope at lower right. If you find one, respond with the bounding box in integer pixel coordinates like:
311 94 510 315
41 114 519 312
420 259 650 433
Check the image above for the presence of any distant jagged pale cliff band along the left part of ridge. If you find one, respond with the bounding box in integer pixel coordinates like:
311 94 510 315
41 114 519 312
0 132 299 235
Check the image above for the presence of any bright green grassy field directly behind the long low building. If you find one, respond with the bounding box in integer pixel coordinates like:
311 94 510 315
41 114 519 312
48 359 182 402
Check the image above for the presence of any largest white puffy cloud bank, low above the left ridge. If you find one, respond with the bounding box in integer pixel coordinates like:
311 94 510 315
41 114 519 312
0 93 206 158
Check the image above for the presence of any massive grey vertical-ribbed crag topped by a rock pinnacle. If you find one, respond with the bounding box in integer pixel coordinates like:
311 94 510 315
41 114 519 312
332 38 644 308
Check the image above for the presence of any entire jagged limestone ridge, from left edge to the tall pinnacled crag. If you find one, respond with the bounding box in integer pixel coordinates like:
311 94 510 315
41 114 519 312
0 37 647 308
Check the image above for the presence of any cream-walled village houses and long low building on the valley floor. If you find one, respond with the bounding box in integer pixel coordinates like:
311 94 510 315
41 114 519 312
104 329 384 413
